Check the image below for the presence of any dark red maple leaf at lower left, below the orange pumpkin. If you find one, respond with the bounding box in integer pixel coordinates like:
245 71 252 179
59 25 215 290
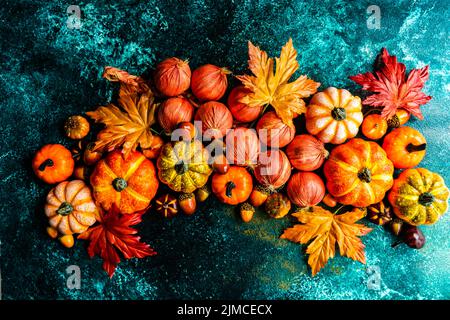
78 206 156 278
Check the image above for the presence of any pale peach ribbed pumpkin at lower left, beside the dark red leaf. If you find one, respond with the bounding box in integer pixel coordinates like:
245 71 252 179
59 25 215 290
45 180 97 237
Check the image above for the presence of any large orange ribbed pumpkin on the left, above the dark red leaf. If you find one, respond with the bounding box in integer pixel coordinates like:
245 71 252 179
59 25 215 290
90 150 159 214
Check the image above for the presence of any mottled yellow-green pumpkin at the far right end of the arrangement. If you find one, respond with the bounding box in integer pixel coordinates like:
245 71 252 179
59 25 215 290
388 168 449 226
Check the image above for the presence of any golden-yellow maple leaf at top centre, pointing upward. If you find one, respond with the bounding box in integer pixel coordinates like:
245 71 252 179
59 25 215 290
237 39 320 125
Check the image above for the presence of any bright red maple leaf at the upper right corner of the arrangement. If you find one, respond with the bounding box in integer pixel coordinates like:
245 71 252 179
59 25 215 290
349 48 431 120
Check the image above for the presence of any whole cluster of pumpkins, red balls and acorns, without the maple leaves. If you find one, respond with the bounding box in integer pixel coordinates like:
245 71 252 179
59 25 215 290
33 58 449 247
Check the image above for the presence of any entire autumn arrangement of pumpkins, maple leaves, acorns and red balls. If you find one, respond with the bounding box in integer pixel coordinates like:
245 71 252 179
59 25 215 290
32 40 449 277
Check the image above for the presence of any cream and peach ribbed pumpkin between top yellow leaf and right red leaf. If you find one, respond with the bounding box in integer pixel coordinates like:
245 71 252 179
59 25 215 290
306 87 363 144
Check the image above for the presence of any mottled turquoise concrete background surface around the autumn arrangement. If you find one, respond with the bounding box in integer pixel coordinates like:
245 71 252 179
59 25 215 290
0 0 450 299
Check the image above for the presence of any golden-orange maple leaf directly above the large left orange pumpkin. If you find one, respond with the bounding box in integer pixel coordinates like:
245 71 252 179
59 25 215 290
87 87 156 156
